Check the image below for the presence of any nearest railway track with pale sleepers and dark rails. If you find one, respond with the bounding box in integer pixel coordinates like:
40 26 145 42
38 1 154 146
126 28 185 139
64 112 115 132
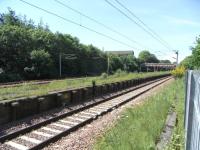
0 77 171 150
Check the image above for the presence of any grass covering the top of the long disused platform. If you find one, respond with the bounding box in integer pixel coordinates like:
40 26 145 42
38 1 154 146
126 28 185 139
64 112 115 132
0 72 169 101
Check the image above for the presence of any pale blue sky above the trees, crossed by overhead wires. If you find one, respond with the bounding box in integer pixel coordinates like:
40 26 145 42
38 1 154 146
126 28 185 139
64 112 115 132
0 0 200 62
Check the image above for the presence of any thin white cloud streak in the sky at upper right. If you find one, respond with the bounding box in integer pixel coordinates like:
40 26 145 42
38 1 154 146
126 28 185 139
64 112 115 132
165 16 200 27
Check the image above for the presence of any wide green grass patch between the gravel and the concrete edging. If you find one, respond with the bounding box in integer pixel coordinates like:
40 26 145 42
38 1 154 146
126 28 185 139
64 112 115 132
94 78 180 150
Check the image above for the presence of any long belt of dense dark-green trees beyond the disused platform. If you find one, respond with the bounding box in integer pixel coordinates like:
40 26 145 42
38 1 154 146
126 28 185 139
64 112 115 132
0 9 170 82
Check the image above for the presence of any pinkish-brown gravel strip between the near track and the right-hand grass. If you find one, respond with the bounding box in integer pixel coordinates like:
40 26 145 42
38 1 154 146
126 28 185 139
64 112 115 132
43 79 173 150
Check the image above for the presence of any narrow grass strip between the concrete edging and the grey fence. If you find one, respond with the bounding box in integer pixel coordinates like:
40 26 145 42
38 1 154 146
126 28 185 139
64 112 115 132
167 79 185 150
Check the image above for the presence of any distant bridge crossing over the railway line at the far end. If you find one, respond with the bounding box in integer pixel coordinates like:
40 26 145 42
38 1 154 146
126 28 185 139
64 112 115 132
140 63 176 72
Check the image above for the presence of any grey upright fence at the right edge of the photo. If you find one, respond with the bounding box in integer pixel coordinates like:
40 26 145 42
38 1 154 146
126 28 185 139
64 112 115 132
184 70 200 150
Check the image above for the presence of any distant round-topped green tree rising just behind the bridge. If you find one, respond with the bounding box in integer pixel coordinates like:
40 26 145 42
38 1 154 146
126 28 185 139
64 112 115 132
138 50 159 63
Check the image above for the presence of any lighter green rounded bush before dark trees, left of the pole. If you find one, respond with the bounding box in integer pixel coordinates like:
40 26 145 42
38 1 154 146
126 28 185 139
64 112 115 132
31 50 52 78
